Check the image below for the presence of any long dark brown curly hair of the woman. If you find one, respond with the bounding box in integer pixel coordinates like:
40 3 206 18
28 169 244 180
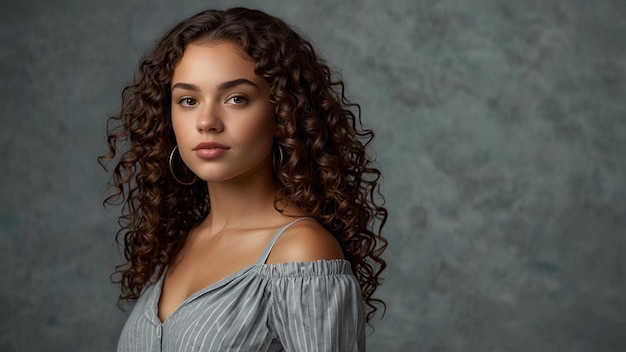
98 8 387 321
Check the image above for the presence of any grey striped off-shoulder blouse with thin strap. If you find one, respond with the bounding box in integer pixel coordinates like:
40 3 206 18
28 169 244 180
117 220 365 352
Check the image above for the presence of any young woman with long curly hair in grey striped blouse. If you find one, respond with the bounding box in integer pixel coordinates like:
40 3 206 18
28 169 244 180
100 8 387 351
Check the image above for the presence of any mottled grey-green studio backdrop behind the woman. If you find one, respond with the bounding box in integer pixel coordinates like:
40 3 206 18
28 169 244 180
0 0 626 352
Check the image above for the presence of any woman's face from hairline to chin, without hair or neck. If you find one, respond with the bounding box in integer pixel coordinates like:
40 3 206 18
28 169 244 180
171 43 276 182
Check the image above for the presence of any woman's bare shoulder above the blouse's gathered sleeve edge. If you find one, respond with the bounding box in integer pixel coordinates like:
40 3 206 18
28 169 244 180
267 220 344 264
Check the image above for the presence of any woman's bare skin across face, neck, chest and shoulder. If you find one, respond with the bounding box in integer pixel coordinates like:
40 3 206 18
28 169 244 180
159 42 343 321
